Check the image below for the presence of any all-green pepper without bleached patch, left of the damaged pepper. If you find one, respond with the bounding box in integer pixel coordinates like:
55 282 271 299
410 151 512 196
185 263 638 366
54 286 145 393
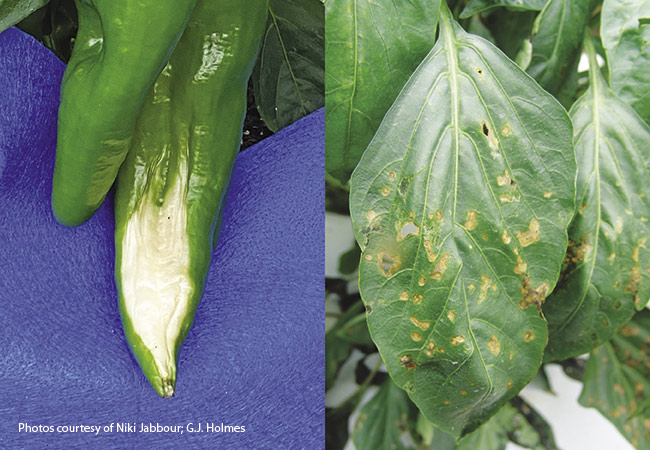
52 0 197 226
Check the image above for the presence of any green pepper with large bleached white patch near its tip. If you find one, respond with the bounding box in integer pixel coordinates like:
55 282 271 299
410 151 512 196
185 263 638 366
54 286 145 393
115 0 267 397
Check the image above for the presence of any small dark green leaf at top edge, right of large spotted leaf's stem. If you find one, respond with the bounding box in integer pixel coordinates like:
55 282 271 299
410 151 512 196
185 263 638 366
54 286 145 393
526 0 590 94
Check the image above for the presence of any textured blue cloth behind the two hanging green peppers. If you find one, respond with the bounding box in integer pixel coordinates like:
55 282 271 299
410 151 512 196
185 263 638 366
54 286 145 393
0 29 324 449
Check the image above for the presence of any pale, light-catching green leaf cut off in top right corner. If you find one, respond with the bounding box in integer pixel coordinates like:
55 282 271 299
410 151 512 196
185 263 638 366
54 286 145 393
601 0 650 123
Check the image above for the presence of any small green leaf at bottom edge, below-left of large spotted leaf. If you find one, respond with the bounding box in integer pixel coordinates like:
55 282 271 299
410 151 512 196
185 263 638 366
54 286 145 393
352 379 417 450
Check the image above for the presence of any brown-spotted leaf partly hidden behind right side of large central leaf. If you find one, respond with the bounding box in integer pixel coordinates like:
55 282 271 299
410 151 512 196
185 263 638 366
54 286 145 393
544 40 650 360
